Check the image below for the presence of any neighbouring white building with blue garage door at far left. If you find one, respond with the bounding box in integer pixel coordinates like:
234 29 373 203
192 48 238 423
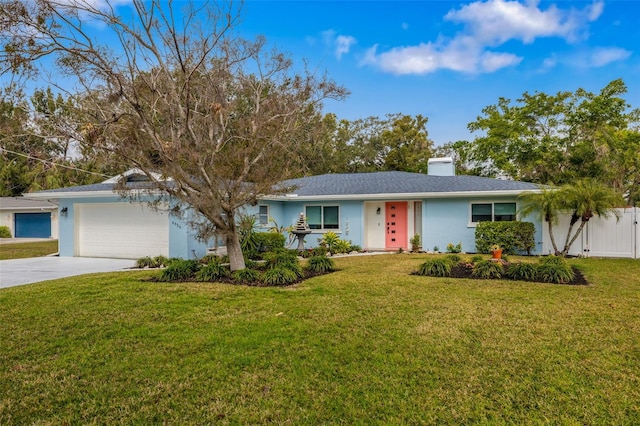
0 197 58 239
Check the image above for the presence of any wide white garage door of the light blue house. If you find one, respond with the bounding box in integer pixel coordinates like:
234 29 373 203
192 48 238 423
75 203 169 259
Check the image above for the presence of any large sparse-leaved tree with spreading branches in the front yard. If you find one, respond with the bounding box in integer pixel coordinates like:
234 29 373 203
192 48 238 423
0 0 346 270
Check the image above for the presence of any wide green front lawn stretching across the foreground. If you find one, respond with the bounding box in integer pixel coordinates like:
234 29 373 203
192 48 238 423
0 255 640 425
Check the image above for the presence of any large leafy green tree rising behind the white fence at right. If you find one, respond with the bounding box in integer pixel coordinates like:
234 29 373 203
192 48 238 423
458 80 640 202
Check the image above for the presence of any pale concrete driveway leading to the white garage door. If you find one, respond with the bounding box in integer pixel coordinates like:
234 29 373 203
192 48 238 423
0 257 136 288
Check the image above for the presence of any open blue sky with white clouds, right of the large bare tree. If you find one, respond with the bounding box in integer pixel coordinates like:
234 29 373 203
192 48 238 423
239 0 640 145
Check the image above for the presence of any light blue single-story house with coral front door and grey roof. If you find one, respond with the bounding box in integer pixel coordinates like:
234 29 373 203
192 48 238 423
30 159 542 258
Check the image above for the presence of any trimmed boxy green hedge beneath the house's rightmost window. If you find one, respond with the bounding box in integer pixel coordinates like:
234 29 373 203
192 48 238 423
476 221 535 255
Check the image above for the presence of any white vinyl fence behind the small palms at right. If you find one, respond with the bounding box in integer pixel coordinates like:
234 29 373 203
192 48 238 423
542 207 640 259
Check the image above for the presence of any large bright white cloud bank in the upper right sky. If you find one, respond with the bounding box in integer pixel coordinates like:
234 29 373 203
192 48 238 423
361 0 608 75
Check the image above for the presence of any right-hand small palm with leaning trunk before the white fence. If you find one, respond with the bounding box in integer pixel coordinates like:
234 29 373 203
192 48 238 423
554 179 625 256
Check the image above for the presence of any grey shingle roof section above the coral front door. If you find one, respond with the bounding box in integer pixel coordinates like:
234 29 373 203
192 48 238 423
283 172 538 196
